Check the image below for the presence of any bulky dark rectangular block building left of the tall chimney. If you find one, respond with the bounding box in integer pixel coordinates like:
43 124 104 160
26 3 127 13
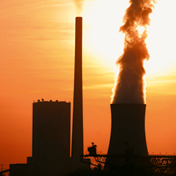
32 101 70 176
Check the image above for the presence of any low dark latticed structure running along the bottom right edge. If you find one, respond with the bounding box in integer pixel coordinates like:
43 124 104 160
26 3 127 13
82 154 176 176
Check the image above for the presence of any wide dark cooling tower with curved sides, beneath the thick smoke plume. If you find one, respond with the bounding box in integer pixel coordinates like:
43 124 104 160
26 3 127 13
108 104 148 155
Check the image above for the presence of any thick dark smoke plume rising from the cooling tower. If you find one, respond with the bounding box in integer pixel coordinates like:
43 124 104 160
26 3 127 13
112 0 154 104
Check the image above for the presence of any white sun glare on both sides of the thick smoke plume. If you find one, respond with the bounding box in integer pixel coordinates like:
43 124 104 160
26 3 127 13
83 0 176 76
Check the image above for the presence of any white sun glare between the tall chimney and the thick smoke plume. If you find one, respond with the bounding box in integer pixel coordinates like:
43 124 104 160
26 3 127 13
83 0 128 68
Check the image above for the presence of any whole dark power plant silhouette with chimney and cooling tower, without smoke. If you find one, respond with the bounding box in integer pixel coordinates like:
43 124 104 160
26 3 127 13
0 10 176 176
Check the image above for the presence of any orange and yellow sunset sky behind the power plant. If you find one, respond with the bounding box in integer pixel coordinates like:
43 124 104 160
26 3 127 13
0 0 176 168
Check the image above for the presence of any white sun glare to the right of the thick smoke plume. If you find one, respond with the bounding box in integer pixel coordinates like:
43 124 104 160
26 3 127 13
145 0 176 76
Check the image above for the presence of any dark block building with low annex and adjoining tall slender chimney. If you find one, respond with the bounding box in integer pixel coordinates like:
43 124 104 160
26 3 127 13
7 17 89 176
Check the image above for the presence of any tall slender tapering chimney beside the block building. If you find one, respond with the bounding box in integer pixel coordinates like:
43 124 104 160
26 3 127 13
72 17 83 159
